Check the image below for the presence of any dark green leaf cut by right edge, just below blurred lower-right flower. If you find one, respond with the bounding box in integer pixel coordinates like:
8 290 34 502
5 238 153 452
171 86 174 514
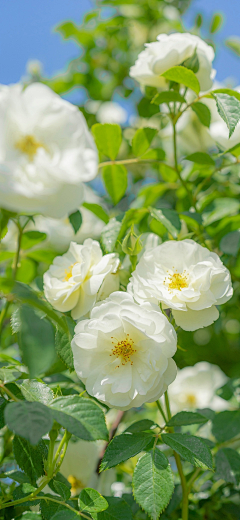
212 410 240 442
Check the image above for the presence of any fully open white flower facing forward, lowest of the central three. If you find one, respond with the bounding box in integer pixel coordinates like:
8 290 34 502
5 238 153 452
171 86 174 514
72 292 177 410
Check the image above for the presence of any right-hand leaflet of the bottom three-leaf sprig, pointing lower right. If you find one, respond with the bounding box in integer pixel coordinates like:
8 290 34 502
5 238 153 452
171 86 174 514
162 433 213 469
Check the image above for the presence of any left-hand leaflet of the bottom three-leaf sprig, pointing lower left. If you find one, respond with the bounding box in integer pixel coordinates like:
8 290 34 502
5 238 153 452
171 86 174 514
100 432 153 471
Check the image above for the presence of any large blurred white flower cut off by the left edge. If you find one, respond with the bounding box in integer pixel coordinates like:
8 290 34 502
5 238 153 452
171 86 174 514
0 83 98 218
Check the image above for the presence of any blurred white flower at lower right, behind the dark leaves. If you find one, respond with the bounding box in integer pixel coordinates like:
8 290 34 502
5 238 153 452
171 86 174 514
168 361 227 413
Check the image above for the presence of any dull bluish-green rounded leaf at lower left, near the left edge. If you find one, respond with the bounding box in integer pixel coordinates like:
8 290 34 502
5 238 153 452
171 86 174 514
4 401 53 445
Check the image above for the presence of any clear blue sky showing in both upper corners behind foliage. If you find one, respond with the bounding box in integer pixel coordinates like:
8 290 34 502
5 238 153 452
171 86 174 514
0 0 240 89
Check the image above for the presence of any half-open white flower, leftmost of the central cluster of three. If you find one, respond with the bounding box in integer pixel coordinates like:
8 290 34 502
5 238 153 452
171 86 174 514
44 238 119 320
